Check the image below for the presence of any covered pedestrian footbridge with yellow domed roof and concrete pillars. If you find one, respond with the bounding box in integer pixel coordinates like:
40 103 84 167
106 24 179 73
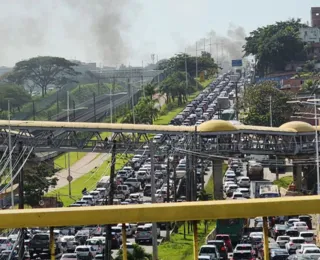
0 120 319 199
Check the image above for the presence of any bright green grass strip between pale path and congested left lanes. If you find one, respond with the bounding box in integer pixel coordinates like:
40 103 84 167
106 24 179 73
46 155 131 206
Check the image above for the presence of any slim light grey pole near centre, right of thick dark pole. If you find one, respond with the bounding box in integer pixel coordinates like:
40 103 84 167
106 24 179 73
149 142 158 260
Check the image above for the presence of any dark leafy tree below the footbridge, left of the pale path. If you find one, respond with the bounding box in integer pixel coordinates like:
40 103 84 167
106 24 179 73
24 163 58 206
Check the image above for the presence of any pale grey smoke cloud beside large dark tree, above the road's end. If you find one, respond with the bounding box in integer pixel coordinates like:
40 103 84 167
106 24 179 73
187 24 246 68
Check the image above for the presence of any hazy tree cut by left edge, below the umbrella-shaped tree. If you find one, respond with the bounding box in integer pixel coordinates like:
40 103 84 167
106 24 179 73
0 83 31 110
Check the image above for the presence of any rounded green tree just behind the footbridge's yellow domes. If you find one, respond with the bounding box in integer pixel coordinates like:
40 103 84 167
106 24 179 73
238 81 297 127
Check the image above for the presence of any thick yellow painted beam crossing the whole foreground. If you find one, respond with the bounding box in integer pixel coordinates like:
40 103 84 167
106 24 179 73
0 196 320 228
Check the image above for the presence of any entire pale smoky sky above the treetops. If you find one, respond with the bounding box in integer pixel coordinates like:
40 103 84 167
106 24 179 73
0 0 320 66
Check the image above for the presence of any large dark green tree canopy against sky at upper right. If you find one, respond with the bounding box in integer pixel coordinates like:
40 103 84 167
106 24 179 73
243 19 307 76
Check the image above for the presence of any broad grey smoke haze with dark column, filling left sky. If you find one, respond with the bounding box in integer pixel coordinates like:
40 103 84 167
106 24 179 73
0 0 138 65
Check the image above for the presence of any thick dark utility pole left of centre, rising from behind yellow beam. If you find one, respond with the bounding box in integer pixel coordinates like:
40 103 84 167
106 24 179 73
104 140 117 260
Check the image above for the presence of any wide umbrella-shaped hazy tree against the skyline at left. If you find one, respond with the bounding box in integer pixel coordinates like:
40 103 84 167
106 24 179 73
8 56 81 96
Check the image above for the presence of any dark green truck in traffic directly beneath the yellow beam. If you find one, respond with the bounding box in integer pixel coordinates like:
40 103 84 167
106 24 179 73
216 218 247 245
